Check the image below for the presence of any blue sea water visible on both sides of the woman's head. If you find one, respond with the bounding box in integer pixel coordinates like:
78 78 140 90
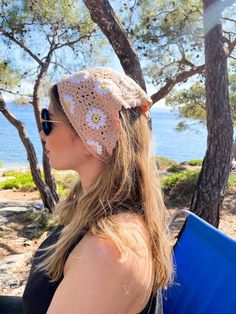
0 104 207 166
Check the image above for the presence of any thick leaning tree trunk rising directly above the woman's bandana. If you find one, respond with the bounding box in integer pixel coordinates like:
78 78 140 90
83 0 146 91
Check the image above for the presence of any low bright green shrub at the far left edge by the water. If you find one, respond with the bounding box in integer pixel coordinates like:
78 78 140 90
0 173 36 192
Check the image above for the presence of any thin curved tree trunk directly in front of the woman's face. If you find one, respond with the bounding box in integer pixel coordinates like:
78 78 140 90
33 60 59 202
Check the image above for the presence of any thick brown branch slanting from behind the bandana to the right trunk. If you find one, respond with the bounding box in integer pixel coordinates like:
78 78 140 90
151 64 205 103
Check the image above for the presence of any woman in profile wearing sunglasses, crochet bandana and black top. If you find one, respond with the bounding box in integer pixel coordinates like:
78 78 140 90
23 68 172 314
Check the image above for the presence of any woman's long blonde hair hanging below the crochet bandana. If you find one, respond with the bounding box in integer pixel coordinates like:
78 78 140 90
39 87 172 290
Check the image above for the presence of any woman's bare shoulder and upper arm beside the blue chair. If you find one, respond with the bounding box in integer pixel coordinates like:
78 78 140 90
48 214 153 314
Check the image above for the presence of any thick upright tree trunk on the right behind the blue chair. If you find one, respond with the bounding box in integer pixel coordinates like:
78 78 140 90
190 0 233 227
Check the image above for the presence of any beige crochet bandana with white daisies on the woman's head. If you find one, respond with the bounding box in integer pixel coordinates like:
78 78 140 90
57 68 152 161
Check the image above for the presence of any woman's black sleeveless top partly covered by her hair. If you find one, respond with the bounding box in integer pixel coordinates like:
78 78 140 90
23 226 162 314
